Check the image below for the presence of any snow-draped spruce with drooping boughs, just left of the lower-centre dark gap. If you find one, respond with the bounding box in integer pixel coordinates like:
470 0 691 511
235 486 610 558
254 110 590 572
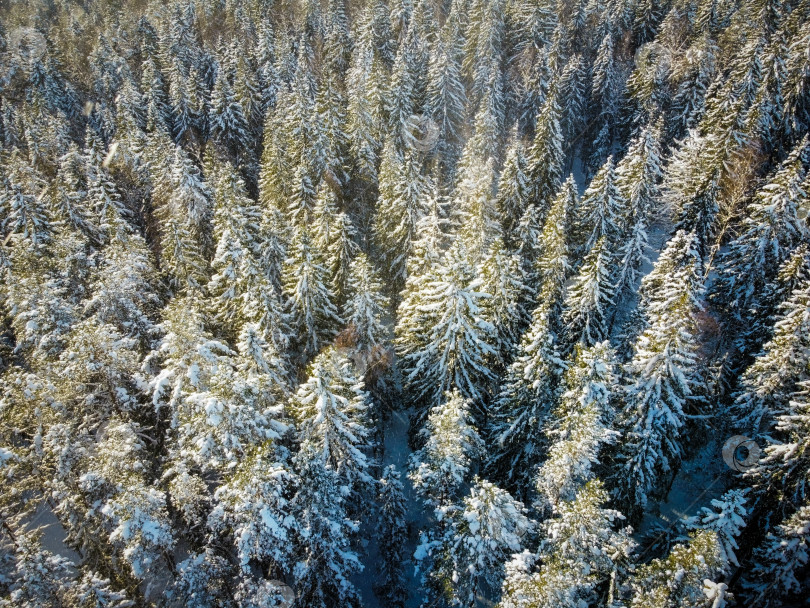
289 347 371 491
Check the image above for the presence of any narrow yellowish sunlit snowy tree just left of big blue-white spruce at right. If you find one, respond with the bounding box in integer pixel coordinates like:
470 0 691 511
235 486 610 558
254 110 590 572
536 342 617 512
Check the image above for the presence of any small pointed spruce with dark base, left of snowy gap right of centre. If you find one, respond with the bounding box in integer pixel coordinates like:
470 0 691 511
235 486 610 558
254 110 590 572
563 236 615 347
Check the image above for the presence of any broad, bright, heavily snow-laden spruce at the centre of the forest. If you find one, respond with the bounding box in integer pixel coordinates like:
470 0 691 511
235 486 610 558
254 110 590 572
396 241 495 406
